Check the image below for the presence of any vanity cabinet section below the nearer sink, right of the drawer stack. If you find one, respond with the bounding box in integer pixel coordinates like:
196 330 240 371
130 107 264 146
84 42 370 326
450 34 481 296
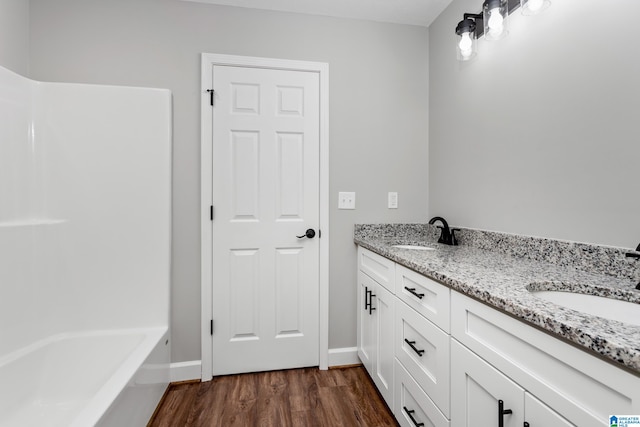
451 291 640 427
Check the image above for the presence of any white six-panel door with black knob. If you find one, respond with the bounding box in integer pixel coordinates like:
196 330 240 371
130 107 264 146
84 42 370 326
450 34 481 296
212 66 320 375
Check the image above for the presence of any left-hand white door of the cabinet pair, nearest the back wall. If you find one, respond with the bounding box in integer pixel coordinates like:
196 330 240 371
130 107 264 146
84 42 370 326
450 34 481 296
357 271 377 377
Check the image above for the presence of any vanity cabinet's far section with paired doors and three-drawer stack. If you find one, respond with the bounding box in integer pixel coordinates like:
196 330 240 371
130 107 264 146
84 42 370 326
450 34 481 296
357 248 450 427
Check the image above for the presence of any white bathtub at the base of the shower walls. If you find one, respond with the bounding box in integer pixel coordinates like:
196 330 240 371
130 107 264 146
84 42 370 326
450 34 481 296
0 327 169 427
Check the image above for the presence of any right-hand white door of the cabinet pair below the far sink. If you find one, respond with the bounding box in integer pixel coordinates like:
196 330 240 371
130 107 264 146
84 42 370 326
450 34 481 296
371 285 395 408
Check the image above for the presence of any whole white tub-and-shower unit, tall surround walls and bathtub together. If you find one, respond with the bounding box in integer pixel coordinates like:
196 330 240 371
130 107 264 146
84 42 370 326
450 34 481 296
0 68 171 426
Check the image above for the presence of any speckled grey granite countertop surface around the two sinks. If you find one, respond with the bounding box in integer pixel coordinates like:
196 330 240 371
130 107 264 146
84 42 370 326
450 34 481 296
354 227 640 375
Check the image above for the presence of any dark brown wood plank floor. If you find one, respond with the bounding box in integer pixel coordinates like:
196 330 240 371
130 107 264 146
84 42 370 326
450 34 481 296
148 366 398 427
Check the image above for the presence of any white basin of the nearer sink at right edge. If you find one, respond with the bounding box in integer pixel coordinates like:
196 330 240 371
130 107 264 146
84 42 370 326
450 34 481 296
529 290 640 326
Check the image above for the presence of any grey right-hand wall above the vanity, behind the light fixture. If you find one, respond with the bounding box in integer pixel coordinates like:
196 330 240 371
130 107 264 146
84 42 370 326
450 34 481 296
429 0 640 248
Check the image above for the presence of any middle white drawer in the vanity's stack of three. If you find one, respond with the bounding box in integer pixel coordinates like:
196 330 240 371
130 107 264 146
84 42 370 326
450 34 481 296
395 301 450 417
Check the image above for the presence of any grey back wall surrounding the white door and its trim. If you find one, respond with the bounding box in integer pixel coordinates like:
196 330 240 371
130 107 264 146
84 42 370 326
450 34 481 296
30 0 429 362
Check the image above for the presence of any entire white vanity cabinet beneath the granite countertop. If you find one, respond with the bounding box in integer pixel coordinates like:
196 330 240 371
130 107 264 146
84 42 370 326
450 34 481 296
358 247 640 427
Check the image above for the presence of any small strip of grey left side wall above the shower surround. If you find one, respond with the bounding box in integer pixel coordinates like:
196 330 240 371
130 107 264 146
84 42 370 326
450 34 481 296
0 0 29 75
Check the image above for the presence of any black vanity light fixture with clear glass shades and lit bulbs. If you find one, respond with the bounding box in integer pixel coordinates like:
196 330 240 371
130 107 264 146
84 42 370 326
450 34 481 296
456 0 551 61
